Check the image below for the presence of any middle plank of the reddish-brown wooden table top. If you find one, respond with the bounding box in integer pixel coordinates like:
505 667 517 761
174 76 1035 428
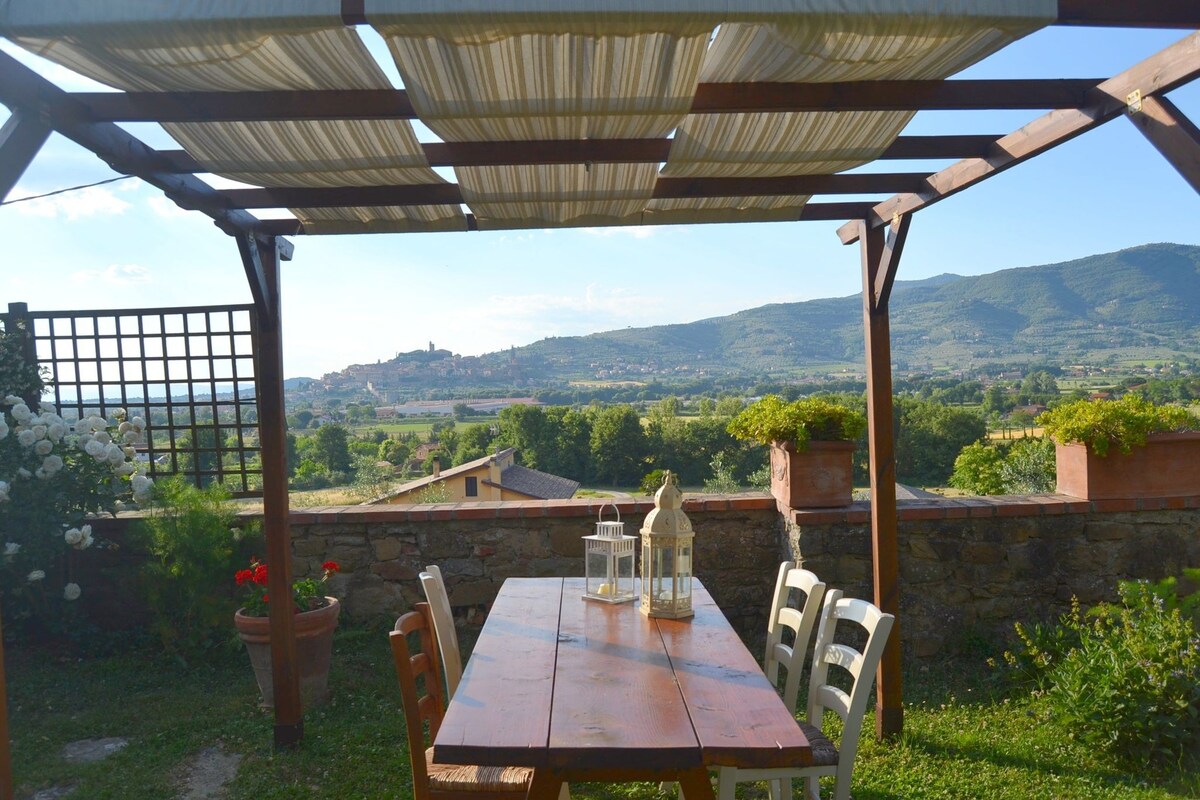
550 578 702 769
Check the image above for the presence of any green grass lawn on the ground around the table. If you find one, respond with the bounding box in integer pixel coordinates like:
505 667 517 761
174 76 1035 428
7 626 1200 800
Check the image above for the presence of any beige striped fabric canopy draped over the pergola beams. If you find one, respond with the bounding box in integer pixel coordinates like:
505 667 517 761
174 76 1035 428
0 0 1057 233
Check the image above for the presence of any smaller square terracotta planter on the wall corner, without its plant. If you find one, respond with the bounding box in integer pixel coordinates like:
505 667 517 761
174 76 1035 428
770 441 854 509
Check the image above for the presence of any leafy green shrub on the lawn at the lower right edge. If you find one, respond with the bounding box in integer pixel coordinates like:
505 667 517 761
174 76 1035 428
1006 582 1200 760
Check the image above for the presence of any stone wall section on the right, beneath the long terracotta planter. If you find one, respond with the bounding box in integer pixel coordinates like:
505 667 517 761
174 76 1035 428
786 494 1200 658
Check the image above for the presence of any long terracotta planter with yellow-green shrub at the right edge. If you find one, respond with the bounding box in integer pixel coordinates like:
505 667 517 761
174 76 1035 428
1037 395 1200 500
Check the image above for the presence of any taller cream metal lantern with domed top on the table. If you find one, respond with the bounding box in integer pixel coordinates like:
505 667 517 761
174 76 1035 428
642 473 696 619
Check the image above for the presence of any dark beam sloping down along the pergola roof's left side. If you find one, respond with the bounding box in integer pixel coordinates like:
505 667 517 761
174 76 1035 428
0 53 288 245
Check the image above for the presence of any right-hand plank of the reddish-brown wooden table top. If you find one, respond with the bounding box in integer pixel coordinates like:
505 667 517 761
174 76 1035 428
656 581 811 768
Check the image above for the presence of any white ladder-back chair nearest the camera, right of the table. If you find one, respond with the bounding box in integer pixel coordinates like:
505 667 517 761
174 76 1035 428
716 589 895 800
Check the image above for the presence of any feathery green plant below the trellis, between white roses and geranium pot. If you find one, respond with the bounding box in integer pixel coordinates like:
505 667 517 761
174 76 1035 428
132 477 247 662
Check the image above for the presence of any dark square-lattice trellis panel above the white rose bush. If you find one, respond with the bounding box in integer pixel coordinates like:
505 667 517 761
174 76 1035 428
5 303 263 497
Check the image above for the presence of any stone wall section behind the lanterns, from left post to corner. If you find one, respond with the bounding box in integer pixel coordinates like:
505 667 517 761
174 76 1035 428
285 494 784 636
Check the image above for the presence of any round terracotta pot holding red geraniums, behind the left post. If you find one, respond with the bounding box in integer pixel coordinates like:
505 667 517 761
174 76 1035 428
233 597 342 708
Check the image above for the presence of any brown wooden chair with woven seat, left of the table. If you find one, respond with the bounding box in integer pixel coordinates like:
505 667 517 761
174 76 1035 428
389 603 533 800
